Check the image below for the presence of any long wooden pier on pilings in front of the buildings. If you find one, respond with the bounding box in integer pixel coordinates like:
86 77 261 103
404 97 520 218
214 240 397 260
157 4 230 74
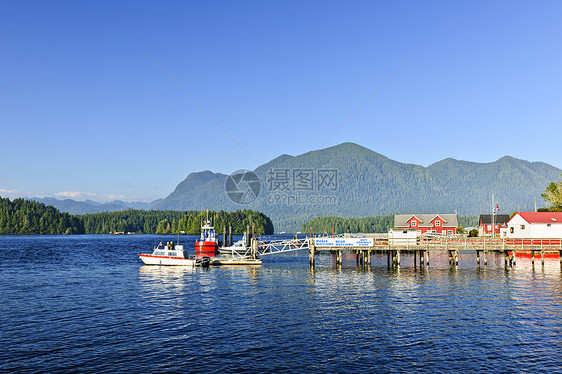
308 238 562 269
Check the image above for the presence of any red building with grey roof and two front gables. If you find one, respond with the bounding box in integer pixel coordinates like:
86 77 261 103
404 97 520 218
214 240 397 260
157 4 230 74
394 214 458 235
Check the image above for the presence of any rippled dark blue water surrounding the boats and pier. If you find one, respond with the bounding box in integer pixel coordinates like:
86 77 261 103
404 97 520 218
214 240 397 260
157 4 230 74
0 235 562 373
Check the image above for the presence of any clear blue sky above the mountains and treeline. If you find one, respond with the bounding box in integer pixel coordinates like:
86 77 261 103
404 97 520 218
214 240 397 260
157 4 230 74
0 0 562 201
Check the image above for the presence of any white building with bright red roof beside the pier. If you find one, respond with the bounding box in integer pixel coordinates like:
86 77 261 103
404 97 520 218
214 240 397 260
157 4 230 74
503 212 562 239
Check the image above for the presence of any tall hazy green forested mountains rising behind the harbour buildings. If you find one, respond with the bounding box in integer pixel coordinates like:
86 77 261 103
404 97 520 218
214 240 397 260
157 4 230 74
155 143 562 232
